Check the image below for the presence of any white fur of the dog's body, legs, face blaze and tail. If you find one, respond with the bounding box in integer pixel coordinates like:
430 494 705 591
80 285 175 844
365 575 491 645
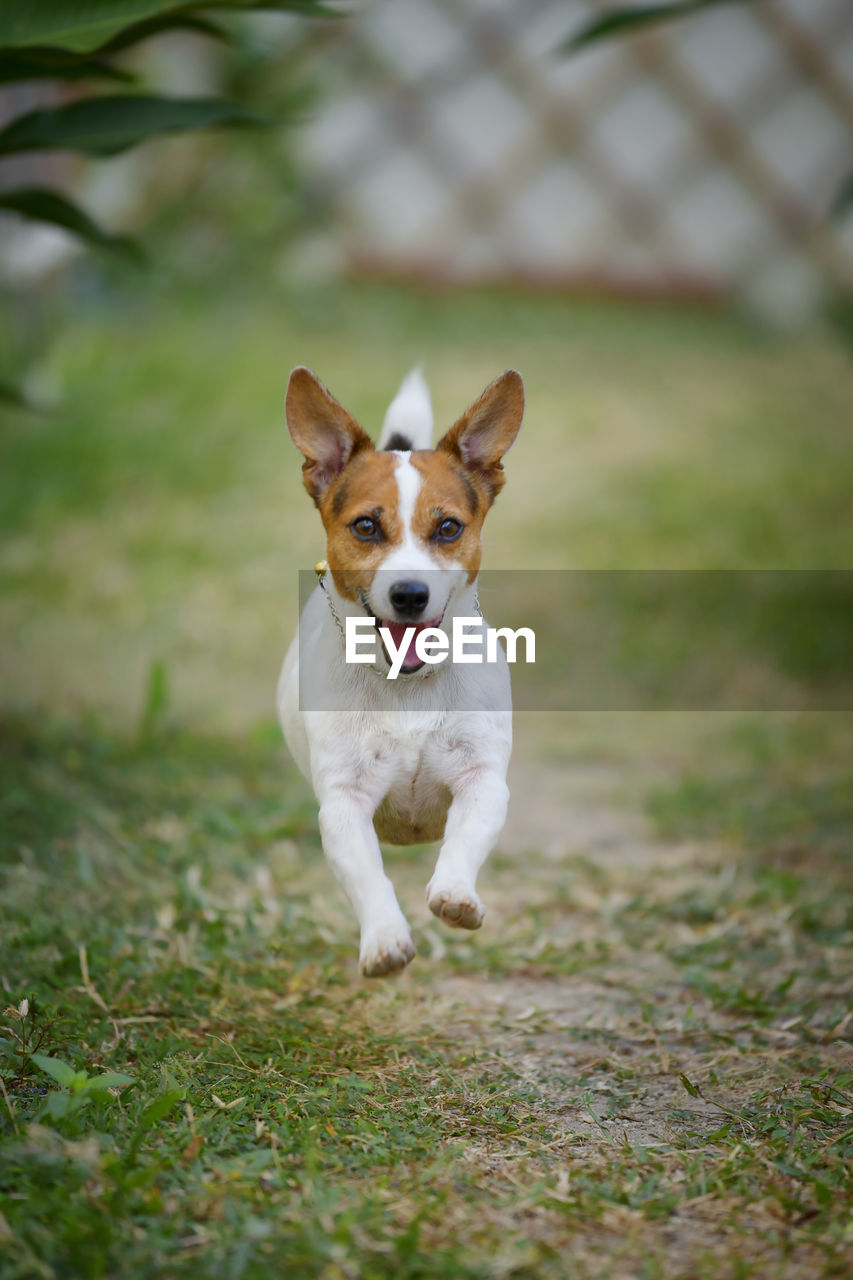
277 371 512 975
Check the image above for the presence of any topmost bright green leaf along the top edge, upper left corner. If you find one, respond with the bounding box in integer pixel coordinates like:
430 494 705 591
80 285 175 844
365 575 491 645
0 0 329 52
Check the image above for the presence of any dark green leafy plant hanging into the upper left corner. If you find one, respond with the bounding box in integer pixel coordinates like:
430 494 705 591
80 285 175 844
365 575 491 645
0 0 329 408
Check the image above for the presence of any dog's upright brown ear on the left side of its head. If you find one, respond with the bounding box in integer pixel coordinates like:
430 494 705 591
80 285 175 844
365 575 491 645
284 365 373 504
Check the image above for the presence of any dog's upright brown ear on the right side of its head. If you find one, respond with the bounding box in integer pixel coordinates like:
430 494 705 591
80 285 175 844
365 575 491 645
435 369 524 498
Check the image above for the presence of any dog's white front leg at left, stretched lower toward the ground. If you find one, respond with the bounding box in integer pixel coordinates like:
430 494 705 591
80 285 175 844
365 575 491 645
320 786 415 978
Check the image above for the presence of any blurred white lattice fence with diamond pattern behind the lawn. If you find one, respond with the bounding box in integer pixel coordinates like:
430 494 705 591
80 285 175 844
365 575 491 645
290 0 853 317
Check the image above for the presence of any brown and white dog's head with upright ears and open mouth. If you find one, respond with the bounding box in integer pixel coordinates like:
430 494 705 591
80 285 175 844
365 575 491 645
286 367 524 671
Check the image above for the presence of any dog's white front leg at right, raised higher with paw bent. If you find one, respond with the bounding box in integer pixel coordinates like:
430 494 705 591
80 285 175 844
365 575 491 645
427 767 510 929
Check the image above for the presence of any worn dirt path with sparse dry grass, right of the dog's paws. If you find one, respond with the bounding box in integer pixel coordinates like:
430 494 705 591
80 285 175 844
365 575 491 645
333 737 850 1280
